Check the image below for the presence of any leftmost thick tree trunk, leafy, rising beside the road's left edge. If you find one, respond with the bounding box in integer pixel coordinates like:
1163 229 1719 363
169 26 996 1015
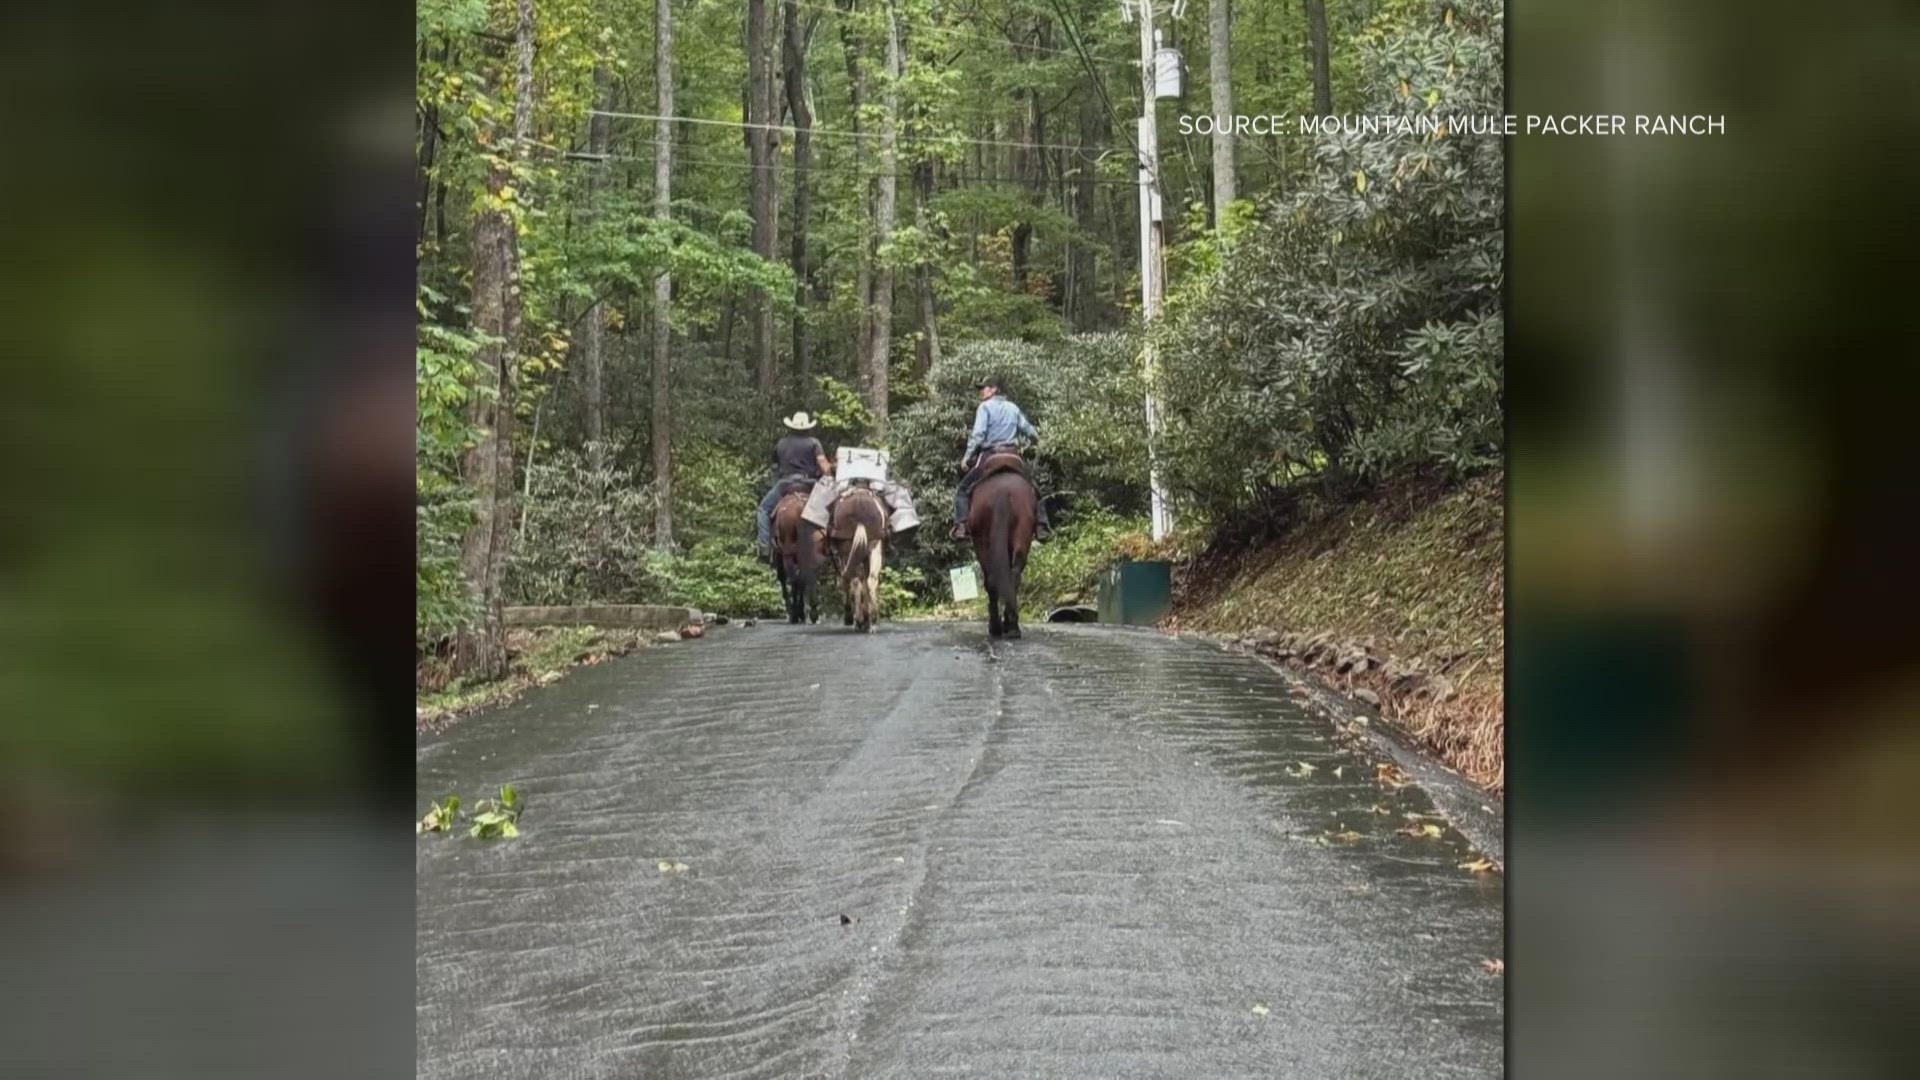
453 0 534 678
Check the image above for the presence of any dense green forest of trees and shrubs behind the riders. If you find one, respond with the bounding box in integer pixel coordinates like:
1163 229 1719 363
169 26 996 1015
417 0 1503 678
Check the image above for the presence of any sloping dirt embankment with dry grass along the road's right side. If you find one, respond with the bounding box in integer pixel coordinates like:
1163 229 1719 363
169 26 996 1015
1169 475 1505 794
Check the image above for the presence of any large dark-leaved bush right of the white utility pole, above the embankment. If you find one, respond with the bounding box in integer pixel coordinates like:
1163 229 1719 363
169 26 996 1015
1160 0 1503 523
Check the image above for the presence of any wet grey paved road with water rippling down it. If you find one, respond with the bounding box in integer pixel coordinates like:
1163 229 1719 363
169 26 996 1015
417 623 1501 1078
